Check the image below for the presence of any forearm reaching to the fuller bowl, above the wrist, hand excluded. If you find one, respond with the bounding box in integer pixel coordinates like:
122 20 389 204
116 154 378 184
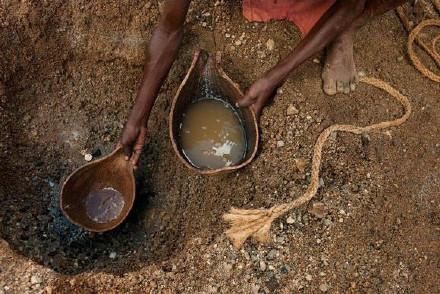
265 1 364 85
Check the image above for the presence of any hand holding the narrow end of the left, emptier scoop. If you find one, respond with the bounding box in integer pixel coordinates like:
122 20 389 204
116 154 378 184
117 122 147 169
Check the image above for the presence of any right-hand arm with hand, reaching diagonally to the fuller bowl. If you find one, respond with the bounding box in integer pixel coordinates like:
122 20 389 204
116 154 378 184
239 0 365 116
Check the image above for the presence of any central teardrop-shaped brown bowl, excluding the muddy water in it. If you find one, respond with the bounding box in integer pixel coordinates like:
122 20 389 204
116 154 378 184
169 50 259 175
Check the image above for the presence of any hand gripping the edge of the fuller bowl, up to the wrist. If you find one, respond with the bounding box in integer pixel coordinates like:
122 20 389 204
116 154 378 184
238 77 277 118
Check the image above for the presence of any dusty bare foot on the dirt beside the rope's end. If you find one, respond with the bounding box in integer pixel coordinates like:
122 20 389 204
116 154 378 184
322 32 358 95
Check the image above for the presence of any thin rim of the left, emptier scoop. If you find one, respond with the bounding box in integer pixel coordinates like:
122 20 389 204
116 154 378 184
59 147 136 233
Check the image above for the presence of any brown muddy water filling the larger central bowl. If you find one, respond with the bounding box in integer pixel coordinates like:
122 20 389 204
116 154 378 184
180 99 246 169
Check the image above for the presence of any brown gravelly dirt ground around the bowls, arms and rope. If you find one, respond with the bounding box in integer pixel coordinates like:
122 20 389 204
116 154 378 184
0 0 440 293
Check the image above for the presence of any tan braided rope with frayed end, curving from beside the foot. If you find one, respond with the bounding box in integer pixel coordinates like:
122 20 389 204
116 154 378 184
223 77 411 249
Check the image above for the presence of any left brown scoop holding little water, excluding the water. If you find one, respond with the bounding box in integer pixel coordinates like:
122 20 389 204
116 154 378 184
60 148 136 232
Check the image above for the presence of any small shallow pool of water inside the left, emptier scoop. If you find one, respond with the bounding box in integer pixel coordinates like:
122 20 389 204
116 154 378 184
85 187 125 224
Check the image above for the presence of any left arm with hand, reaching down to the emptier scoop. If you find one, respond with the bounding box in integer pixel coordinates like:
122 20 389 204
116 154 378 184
119 0 191 167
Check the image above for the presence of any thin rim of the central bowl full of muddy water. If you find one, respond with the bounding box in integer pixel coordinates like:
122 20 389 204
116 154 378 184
168 49 260 175
